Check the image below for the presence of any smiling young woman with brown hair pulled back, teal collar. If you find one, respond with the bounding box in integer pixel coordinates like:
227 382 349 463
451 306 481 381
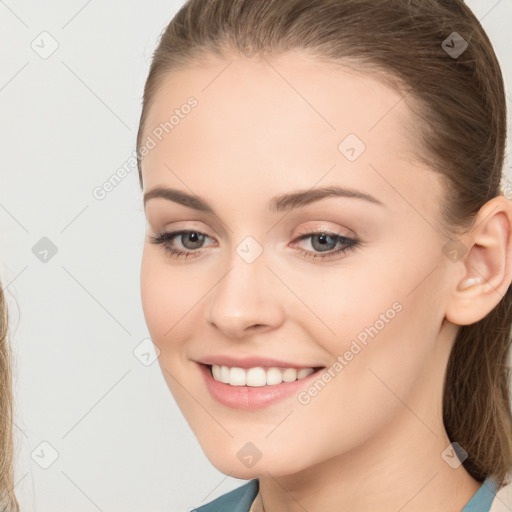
137 0 512 512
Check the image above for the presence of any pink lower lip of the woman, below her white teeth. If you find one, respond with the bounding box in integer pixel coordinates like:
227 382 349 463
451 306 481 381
198 363 320 410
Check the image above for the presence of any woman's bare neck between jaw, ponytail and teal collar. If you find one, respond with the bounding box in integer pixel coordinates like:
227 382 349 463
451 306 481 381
254 328 481 512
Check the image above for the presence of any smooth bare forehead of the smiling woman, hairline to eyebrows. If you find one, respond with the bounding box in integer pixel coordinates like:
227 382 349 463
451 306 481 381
141 52 436 212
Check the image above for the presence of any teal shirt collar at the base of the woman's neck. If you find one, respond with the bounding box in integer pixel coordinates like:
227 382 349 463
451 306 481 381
192 477 498 512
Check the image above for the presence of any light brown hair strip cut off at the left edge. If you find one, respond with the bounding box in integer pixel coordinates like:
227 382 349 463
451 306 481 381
0 284 19 512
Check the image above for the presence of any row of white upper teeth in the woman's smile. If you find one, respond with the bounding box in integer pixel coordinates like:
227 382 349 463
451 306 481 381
212 364 314 387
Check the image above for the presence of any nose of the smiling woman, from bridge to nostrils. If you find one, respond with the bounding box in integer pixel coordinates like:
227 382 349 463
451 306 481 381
207 250 285 339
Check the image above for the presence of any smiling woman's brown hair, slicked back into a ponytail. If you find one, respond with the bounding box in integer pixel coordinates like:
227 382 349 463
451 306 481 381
137 0 512 487
